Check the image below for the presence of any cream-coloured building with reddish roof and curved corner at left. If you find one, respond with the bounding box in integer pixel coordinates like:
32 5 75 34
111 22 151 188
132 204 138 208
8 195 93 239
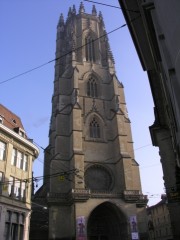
0 104 39 240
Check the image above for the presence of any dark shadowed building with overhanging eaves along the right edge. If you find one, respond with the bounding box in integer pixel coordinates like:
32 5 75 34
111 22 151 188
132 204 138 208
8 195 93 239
119 0 180 240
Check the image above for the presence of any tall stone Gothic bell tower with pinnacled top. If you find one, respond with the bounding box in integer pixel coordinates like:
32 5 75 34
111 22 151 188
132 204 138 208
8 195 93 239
44 3 147 240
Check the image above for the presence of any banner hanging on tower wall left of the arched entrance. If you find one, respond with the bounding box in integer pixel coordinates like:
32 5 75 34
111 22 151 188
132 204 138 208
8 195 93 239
76 216 87 240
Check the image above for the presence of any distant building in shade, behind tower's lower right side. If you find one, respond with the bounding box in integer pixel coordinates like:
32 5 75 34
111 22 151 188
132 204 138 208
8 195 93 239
147 194 173 240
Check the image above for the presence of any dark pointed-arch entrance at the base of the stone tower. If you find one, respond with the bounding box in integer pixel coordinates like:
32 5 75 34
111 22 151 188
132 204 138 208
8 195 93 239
87 202 128 240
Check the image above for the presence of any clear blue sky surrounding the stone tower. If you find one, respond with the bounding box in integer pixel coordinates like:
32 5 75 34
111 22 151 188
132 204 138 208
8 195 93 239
0 0 164 206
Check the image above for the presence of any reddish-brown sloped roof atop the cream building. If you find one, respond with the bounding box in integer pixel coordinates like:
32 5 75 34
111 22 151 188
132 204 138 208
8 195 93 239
0 104 25 131
